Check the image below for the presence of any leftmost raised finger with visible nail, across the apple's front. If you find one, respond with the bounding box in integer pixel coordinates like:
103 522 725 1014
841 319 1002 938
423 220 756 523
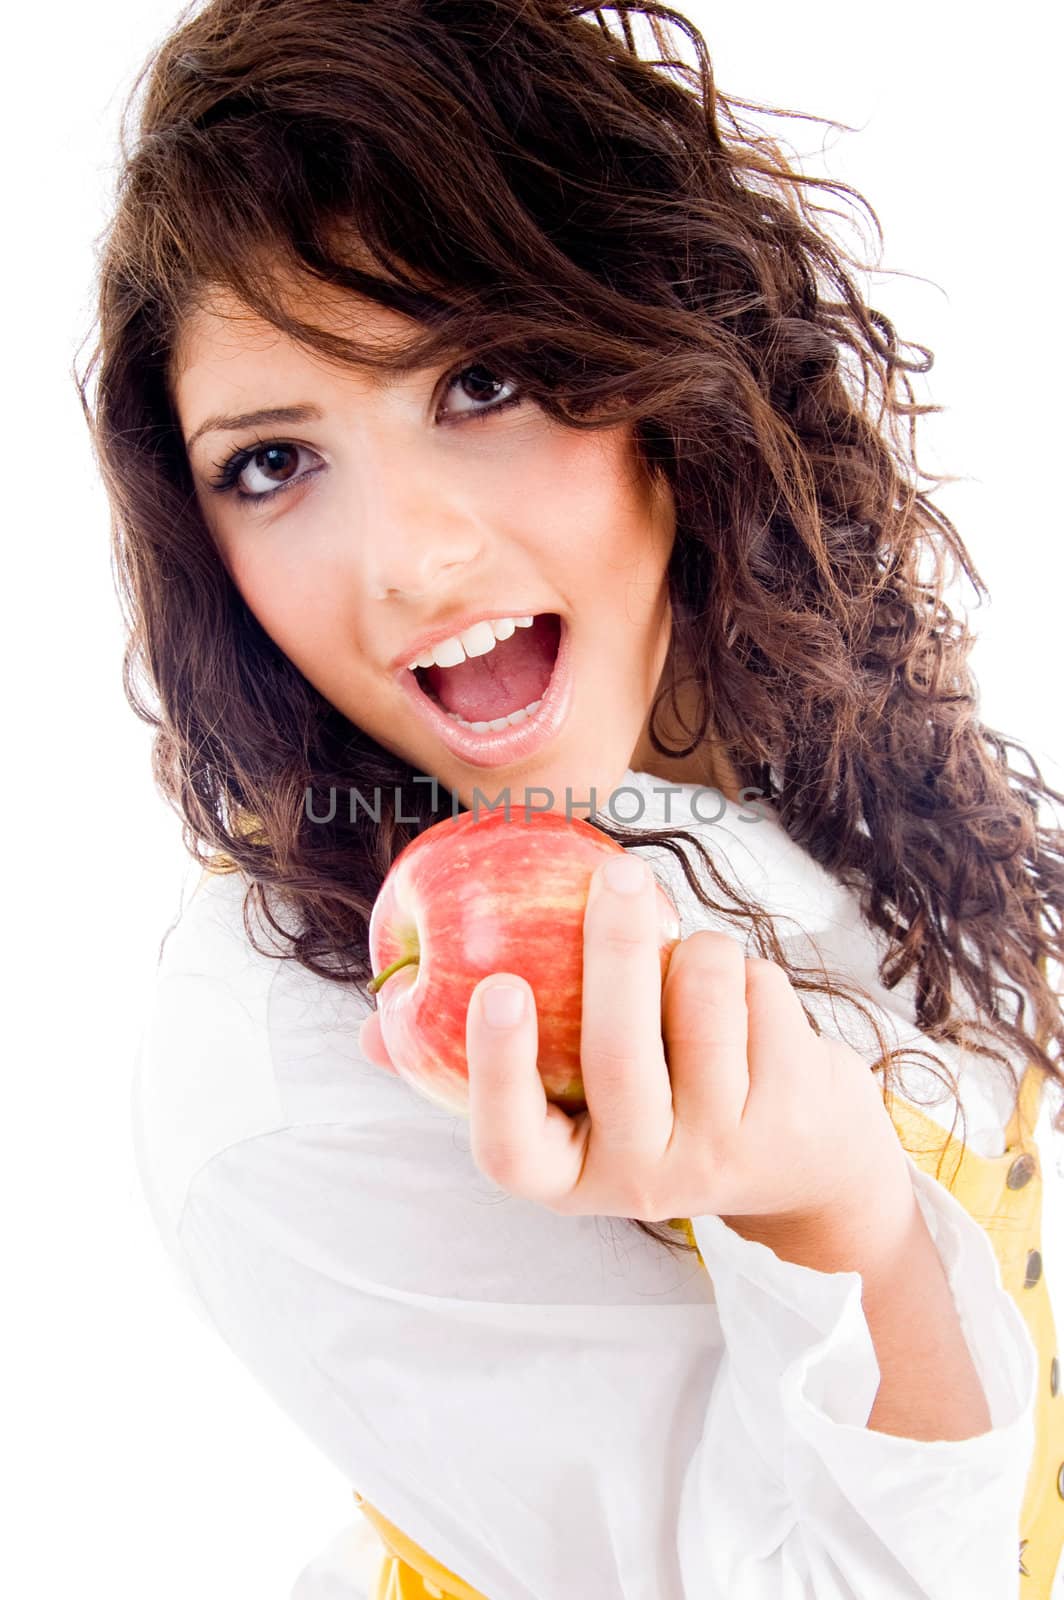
466 973 582 1203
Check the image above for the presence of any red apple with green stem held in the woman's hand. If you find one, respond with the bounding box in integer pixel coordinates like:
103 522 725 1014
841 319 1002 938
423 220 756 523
370 806 680 1115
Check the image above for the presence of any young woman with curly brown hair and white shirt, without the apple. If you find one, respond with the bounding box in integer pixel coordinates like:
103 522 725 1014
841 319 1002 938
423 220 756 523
80 0 1064 1600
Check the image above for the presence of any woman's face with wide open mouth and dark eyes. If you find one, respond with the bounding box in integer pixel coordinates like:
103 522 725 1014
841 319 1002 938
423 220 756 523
171 276 675 816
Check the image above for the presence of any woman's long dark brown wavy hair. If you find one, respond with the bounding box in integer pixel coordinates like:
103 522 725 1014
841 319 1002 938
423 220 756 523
75 0 1064 1248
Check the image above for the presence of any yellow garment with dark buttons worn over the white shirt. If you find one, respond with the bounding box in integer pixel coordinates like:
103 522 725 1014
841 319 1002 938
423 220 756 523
355 1062 1064 1600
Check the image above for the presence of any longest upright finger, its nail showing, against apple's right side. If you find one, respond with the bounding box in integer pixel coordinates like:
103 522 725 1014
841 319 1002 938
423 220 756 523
581 853 672 1166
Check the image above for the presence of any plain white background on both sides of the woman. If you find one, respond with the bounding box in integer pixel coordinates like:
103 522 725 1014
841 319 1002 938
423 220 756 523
0 0 1064 1600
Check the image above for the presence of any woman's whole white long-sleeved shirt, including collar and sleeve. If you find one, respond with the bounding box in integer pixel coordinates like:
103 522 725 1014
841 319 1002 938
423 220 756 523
133 771 1064 1600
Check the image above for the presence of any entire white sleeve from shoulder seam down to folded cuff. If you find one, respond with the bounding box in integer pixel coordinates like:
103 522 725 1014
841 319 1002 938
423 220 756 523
179 1113 1037 1600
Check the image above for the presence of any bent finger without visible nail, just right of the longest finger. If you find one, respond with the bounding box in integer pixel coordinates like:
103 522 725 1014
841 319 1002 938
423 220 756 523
661 930 750 1149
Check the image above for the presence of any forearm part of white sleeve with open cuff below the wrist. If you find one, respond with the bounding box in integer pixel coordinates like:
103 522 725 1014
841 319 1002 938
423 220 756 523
678 1155 1038 1600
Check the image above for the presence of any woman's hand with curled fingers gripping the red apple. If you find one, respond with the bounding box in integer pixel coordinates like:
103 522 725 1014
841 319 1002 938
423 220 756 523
360 853 914 1254
